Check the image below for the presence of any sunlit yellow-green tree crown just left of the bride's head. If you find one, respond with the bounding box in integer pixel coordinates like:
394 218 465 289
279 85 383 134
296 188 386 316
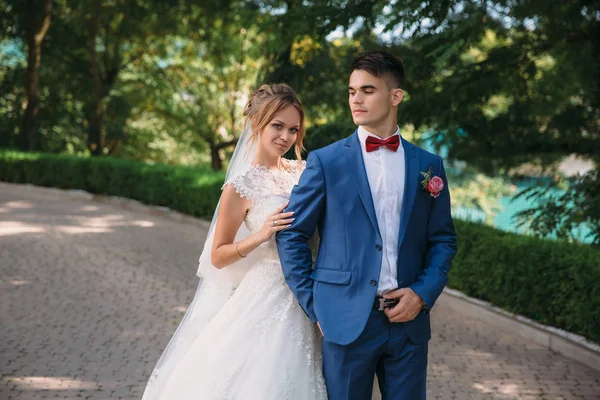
127 8 264 170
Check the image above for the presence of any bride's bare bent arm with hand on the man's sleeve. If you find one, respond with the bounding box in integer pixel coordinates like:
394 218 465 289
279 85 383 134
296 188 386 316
211 185 293 269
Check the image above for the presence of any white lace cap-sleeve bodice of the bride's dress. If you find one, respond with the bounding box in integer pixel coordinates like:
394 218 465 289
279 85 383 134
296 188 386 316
223 160 306 260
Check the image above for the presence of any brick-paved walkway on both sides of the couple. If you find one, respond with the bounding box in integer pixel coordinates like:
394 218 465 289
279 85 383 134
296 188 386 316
0 183 600 400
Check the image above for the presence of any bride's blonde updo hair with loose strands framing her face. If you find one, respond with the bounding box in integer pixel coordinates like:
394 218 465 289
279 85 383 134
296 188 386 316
244 83 304 160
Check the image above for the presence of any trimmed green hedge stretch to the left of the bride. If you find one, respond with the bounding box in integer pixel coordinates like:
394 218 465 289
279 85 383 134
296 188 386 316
0 151 224 218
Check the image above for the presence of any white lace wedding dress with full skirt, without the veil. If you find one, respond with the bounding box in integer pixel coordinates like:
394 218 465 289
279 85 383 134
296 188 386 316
143 162 327 400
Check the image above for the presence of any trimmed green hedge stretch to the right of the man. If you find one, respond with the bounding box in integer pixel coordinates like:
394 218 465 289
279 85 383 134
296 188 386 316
449 221 600 342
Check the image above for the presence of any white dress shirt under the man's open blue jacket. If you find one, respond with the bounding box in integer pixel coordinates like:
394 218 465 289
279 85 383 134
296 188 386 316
358 126 405 295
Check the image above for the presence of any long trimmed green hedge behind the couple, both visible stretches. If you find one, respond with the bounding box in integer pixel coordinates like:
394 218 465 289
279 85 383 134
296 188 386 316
0 151 600 343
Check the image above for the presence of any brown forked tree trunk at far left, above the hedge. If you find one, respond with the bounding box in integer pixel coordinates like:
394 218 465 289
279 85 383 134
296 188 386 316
20 0 52 150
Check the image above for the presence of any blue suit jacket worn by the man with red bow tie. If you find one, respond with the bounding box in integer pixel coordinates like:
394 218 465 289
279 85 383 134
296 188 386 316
277 132 456 345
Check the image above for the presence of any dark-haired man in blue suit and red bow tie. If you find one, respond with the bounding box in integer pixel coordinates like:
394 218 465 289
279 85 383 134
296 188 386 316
277 51 456 400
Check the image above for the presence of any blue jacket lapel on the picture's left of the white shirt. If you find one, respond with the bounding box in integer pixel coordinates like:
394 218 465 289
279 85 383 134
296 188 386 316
345 131 381 236
